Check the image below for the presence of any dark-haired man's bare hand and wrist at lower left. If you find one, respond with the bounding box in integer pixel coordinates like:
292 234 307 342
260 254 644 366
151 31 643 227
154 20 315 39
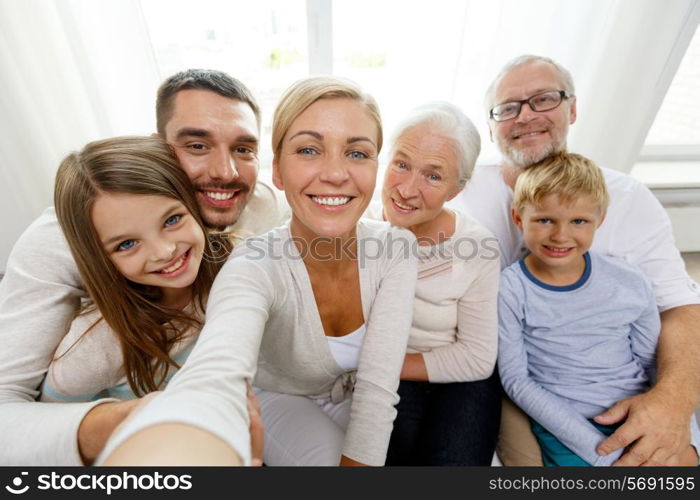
78 399 140 465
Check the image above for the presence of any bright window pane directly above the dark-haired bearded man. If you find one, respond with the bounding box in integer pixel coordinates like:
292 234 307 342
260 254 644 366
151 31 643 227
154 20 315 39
141 0 309 168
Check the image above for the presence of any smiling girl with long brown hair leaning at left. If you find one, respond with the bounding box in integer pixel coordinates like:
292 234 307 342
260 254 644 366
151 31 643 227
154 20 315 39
40 137 230 461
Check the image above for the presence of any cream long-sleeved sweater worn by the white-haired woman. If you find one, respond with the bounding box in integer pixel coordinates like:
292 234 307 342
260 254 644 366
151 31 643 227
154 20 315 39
365 203 500 382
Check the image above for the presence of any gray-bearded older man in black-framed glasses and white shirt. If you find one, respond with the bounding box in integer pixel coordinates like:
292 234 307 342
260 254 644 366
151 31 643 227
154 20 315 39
455 56 700 465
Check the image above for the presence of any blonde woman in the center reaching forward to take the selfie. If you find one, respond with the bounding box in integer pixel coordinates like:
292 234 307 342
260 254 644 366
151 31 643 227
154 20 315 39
98 77 416 465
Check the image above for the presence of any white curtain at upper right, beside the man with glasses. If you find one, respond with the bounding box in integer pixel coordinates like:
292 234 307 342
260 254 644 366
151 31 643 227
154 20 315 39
569 0 700 172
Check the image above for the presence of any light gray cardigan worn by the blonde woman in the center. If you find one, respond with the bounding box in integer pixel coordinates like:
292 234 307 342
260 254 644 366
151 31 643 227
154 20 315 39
103 220 416 465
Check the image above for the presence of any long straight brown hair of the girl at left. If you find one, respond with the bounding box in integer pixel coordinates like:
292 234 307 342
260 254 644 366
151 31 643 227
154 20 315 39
54 137 231 396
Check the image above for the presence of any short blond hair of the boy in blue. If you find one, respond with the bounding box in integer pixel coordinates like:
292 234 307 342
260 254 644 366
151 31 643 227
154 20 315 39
511 152 610 215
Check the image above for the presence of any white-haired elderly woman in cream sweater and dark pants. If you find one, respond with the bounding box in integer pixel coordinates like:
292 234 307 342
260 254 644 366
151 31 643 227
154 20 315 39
370 103 500 465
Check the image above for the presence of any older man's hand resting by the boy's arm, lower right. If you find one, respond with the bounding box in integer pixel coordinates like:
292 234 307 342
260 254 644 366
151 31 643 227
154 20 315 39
594 388 692 466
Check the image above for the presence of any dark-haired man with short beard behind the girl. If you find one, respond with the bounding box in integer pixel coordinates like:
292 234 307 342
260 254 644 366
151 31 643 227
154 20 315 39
0 70 289 465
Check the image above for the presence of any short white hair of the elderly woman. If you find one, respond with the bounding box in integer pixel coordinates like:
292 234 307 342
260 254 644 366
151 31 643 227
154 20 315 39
391 101 481 188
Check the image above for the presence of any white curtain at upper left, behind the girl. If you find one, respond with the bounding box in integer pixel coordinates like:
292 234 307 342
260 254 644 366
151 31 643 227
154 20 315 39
0 0 160 270
